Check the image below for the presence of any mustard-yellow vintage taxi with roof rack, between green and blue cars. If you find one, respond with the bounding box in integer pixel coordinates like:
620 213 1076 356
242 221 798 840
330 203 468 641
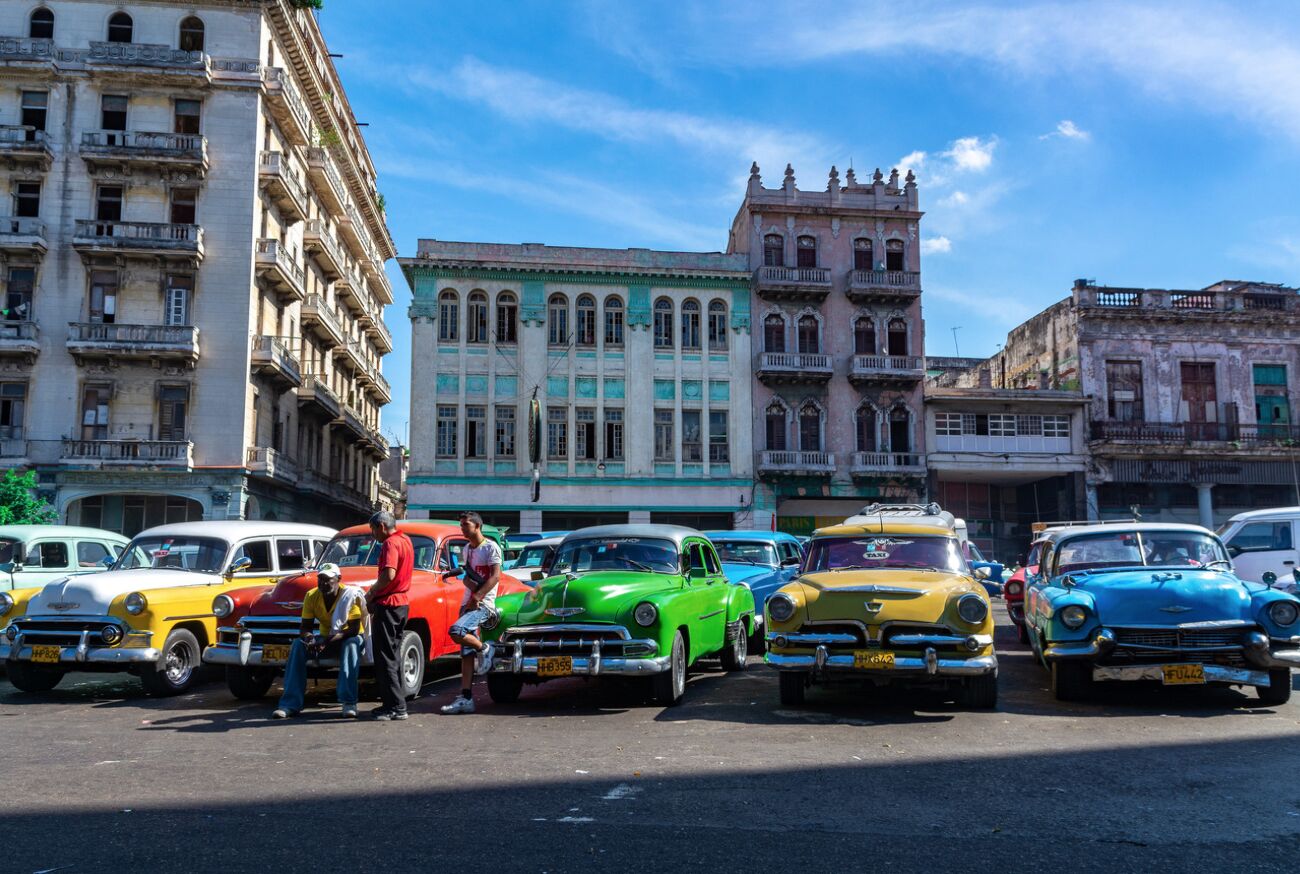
766 503 997 708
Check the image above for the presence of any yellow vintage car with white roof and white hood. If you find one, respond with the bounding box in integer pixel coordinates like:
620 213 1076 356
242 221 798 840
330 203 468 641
0 522 334 695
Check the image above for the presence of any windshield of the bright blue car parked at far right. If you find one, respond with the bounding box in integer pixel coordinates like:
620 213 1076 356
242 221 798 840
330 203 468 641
1053 531 1227 574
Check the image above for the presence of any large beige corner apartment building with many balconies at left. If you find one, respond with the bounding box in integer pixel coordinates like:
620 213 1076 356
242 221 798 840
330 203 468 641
0 0 395 533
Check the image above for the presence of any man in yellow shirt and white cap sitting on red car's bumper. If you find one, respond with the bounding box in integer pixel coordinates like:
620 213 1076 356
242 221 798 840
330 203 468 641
270 564 365 719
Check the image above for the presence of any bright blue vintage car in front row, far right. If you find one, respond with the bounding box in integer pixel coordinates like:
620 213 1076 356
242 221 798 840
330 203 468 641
1024 523 1300 705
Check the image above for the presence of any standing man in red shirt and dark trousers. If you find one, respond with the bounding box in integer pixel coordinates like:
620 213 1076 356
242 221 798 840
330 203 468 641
365 511 415 721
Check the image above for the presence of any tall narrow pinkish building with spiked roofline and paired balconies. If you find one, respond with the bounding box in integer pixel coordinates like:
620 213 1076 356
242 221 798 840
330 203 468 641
728 164 926 533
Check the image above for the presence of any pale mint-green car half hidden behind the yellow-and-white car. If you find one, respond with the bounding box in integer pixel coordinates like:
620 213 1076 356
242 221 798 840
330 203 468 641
0 525 129 590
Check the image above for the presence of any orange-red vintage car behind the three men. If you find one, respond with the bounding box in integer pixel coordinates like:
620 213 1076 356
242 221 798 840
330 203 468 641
203 522 528 698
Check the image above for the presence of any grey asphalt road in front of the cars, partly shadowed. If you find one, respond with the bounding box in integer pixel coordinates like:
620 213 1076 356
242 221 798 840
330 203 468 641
0 608 1300 874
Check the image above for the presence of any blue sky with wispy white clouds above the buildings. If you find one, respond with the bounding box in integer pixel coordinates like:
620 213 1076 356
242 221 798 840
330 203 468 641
320 0 1300 442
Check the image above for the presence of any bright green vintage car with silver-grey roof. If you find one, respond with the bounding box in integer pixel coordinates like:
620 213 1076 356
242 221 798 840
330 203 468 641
486 525 754 705
